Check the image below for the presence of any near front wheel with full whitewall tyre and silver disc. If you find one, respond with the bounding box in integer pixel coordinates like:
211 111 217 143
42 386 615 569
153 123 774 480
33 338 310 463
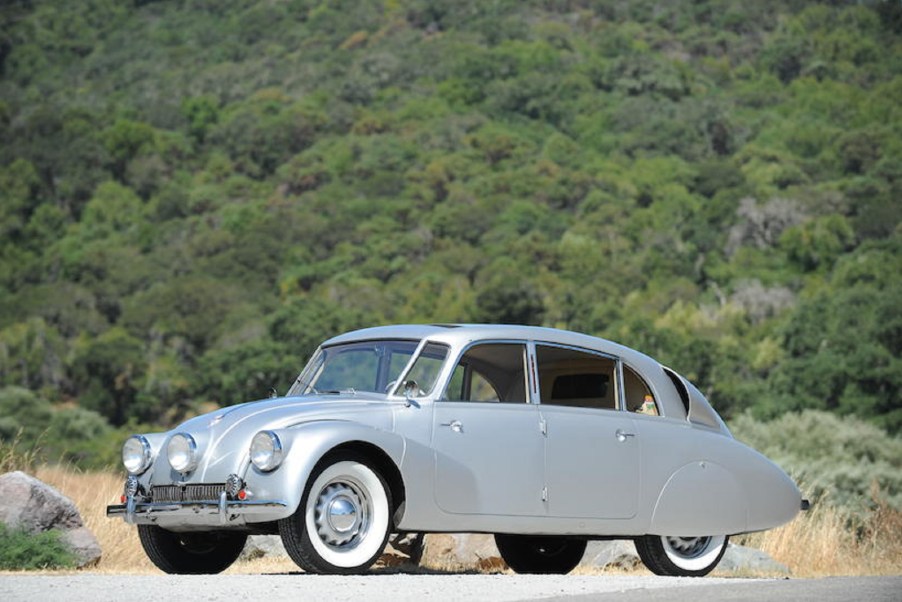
279 457 391 574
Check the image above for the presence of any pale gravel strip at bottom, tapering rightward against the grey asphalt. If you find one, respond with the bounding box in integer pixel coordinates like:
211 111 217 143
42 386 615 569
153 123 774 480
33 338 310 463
0 574 753 602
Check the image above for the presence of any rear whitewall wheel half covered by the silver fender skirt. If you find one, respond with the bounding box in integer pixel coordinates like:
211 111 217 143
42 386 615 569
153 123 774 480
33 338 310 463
635 535 730 577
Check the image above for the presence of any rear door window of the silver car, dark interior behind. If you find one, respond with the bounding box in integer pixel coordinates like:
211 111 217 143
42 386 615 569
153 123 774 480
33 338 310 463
536 345 617 410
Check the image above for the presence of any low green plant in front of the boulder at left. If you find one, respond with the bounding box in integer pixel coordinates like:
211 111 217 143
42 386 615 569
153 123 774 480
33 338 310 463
0 523 76 571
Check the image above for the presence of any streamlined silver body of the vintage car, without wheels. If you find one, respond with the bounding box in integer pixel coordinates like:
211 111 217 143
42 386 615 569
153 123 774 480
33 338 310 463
107 325 802 538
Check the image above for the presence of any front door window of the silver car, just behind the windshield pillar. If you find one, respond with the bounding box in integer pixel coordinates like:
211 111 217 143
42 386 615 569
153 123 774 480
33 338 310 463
442 343 526 403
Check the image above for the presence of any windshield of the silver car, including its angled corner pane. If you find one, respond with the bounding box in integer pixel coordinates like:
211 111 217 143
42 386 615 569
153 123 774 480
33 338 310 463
288 340 444 395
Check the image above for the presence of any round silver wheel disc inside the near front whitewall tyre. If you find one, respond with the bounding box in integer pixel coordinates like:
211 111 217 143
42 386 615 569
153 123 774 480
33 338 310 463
314 481 371 548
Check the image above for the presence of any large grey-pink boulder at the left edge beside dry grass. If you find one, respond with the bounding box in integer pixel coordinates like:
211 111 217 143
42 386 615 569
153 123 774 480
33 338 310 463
0 471 102 568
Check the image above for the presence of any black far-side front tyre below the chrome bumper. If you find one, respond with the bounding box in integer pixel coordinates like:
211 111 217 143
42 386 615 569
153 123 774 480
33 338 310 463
138 525 247 575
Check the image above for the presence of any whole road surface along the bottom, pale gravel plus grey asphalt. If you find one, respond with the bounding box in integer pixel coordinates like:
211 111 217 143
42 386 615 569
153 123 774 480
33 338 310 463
0 573 902 602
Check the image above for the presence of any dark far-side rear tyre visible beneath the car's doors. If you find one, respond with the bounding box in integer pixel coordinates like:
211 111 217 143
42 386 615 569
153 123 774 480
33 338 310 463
495 533 586 575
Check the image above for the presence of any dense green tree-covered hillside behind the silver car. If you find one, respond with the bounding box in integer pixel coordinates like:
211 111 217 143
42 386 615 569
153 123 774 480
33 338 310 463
0 0 902 468
